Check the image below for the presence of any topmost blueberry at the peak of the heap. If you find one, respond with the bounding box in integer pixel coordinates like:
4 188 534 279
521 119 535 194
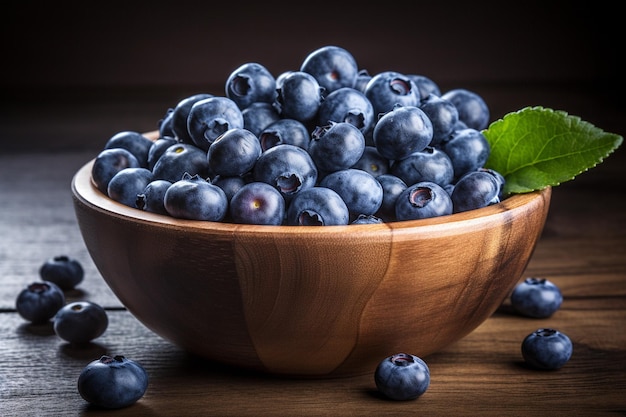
300 45 359 94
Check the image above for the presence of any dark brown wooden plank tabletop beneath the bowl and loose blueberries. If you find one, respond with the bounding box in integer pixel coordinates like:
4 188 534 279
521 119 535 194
0 86 626 416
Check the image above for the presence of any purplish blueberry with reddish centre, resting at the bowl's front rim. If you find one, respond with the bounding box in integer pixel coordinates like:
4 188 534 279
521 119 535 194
230 181 285 226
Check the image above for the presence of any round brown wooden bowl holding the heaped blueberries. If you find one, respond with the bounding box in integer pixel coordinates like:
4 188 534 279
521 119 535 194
72 161 551 377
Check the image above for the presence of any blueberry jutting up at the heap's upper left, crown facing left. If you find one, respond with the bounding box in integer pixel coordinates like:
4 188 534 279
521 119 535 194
225 62 276 110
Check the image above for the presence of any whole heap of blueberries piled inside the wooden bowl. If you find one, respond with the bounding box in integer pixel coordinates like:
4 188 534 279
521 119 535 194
91 45 504 225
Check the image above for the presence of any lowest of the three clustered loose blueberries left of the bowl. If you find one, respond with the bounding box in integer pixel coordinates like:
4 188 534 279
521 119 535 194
54 301 109 344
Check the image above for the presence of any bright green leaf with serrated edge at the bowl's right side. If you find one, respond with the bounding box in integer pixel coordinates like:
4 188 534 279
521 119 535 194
482 107 624 195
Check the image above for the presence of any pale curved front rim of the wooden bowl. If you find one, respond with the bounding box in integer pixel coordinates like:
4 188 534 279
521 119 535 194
71 154 552 235
